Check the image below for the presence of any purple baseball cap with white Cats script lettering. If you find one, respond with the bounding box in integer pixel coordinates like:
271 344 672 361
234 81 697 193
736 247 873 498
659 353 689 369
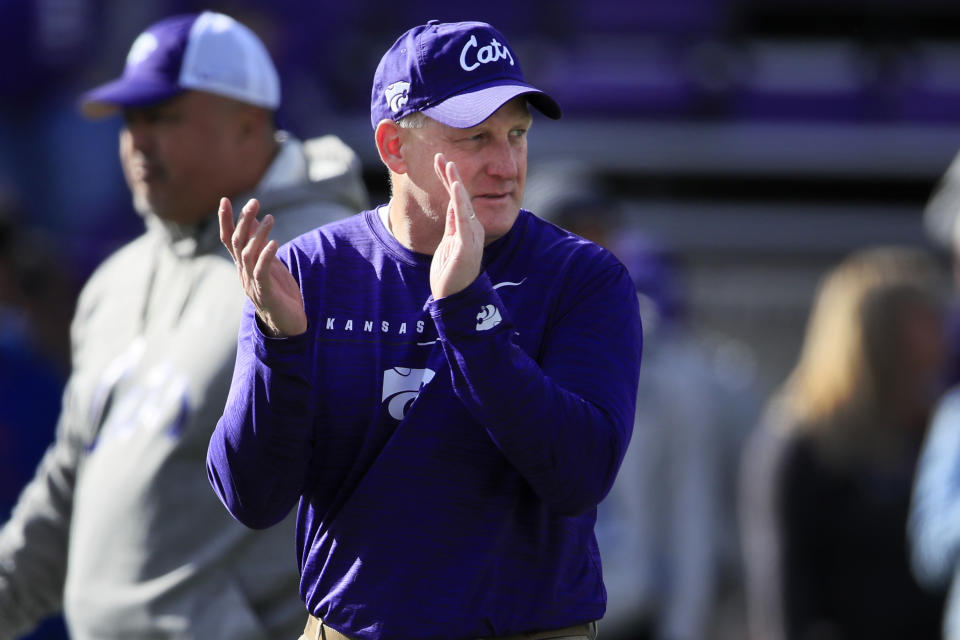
370 20 562 129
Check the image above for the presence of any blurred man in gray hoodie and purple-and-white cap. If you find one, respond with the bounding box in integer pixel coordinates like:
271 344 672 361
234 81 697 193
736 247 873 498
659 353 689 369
0 12 366 639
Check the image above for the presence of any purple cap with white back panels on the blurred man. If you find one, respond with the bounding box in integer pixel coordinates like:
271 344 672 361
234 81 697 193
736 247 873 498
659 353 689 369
80 11 280 118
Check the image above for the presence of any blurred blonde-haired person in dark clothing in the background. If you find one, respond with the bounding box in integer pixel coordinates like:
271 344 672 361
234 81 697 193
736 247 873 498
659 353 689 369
740 247 944 640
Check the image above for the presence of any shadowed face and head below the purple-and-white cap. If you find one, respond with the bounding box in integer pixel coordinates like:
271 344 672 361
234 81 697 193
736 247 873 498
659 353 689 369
120 91 251 224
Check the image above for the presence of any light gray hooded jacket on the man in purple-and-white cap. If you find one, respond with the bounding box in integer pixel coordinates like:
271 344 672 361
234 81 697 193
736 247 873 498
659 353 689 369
0 135 367 640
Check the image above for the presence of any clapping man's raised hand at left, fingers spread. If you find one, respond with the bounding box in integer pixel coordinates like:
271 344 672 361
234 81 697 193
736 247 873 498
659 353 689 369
218 198 307 338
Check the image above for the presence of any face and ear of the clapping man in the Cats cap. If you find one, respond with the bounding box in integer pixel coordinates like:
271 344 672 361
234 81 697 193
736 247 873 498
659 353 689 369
406 97 531 242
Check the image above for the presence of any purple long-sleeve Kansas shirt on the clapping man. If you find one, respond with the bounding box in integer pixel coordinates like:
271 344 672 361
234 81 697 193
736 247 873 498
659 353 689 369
207 211 642 640
